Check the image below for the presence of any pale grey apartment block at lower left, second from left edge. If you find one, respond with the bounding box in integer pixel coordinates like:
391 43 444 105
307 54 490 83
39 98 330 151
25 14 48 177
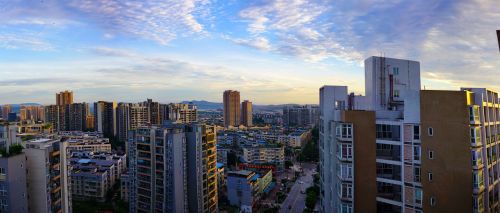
24 138 72 213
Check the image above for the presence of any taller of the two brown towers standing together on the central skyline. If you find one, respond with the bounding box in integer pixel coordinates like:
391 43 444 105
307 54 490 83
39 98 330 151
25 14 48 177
223 90 241 127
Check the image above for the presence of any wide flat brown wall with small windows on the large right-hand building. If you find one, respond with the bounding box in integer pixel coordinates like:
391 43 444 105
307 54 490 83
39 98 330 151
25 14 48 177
420 90 472 212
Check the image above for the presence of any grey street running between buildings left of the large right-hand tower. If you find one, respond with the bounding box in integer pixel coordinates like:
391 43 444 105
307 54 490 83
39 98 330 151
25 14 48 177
280 163 316 213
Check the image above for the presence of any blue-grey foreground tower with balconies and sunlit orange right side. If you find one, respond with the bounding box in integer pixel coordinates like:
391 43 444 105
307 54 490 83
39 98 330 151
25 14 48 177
128 124 217 212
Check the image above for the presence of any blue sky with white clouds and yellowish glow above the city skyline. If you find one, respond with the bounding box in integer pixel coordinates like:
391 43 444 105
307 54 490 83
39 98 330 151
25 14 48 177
0 0 500 104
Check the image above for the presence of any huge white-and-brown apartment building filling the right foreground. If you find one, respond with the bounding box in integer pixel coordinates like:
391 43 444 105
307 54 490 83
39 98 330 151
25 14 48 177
320 57 500 213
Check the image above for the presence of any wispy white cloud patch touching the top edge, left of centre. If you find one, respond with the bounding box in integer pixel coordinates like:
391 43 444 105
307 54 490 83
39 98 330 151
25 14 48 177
65 0 209 45
